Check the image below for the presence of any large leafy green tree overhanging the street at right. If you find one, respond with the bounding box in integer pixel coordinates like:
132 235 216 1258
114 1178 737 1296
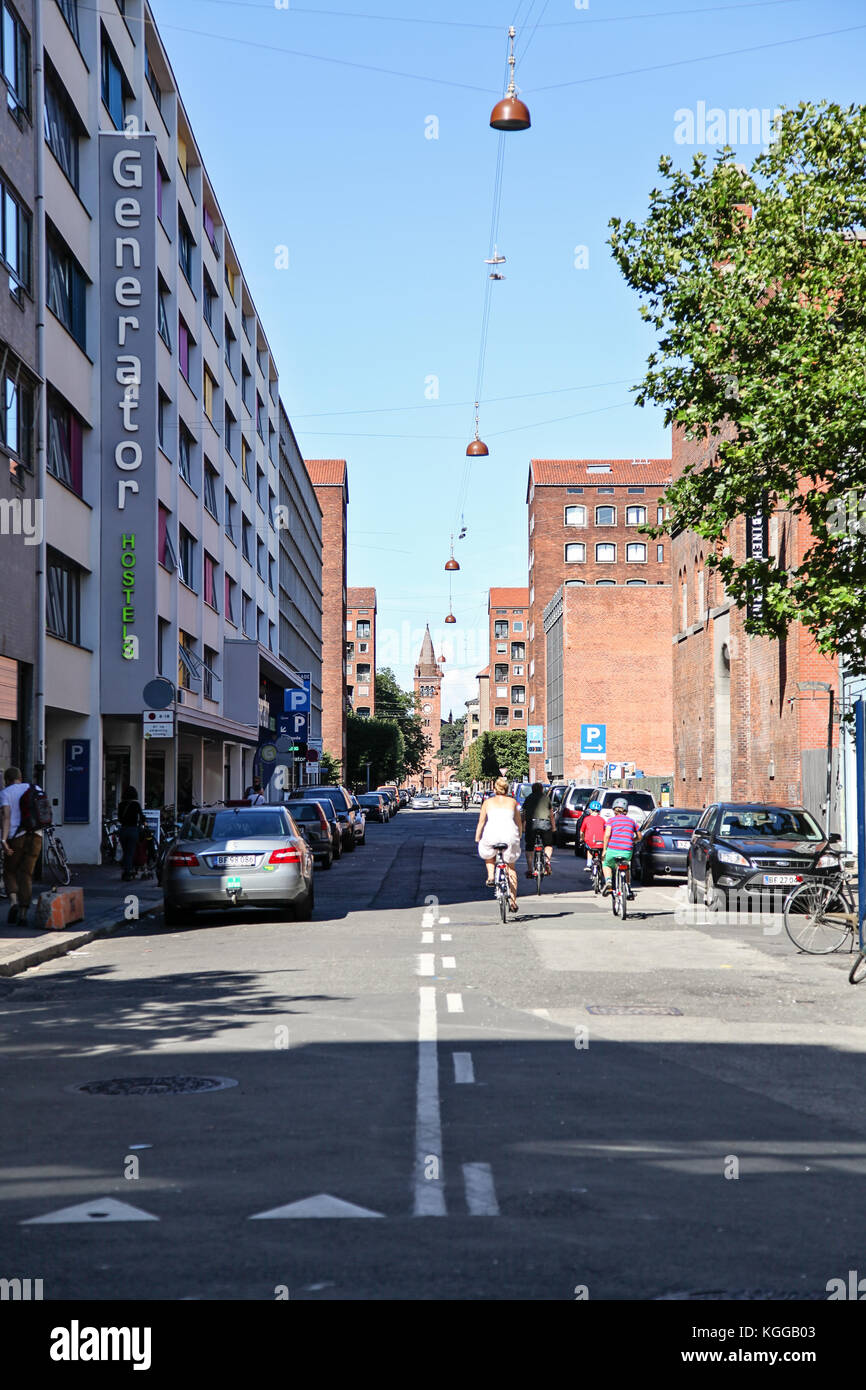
610 101 866 669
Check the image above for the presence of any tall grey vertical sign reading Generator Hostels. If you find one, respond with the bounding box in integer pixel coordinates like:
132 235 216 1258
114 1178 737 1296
99 132 157 714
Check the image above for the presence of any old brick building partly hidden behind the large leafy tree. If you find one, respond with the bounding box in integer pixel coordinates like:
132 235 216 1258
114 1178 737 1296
671 430 840 830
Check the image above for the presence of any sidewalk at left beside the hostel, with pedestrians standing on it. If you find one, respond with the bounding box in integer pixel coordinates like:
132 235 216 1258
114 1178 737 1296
0 865 163 977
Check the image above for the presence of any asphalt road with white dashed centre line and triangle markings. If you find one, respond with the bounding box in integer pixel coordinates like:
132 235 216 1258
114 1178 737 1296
0 810 866 1300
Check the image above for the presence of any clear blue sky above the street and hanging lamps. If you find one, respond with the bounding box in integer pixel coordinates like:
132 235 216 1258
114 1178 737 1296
152 0 866 714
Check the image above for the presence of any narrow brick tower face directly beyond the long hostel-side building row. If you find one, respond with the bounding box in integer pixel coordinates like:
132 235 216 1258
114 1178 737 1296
306 459 349 776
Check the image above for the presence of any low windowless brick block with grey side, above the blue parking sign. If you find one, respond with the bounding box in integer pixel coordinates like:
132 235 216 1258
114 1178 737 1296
544 584 673 783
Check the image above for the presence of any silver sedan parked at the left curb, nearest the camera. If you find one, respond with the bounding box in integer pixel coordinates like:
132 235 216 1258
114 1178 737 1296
163 806 316 927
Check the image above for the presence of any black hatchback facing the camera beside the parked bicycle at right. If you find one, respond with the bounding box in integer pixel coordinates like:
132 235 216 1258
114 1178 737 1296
687 802 841 910
